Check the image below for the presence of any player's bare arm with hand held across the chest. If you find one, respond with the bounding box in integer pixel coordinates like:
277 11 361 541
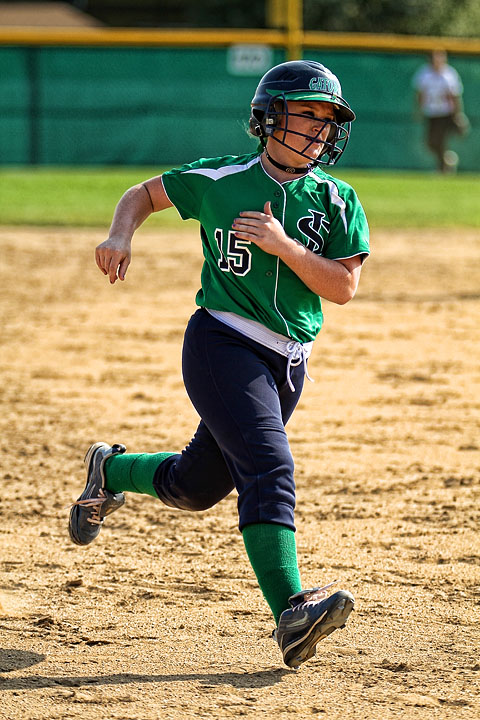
232 202 362 305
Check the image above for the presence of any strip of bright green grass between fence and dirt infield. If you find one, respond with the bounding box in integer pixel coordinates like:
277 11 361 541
0 167 480 229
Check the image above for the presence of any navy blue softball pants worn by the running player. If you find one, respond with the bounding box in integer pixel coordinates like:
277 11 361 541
154 309 304 530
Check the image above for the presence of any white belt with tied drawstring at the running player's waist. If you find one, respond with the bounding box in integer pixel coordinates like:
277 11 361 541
205 308 314 392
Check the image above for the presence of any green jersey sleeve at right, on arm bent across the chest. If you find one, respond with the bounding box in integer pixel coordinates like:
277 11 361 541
323 182 370 260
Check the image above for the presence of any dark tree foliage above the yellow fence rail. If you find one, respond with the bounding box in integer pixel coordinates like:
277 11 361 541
10 0 480 37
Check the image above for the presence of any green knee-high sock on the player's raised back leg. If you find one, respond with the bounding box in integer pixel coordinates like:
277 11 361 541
104 453 176 498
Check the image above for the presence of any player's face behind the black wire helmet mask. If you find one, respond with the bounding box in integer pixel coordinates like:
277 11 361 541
275 100 335 162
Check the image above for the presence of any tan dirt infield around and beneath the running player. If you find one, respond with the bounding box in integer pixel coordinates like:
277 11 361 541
0 224 480 720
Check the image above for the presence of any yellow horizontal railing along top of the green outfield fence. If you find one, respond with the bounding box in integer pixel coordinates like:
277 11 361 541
0 26 480 55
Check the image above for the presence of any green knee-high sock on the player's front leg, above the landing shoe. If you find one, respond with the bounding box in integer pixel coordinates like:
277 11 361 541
242 523 302 625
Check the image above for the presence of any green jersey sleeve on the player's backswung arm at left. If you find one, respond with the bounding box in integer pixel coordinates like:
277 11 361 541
162 160 212 220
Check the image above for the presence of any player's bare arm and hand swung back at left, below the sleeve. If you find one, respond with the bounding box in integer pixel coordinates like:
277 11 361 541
95 176 172 284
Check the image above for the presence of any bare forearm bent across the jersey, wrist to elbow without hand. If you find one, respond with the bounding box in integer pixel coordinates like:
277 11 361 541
280 240 358 305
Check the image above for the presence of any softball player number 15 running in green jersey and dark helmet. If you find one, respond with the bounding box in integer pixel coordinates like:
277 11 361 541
69 61 369 668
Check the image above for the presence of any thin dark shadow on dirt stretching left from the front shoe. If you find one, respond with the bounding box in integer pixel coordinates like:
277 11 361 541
0 668 291 691
